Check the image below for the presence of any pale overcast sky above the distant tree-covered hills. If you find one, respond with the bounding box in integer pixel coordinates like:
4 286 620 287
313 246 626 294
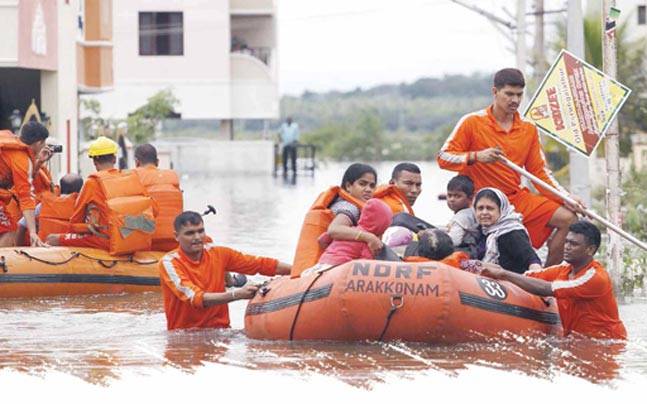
277 0 563 94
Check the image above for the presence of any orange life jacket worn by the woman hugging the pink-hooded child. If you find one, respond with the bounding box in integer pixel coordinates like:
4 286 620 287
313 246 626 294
290 186 365 278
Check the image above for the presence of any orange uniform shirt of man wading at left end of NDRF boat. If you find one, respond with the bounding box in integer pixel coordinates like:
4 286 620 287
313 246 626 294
159 244 278 330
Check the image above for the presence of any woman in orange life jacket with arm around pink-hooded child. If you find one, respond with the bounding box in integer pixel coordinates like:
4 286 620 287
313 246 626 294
291 163 382 278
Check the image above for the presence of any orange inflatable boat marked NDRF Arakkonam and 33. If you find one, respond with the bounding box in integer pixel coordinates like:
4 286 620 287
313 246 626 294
245 260 561 343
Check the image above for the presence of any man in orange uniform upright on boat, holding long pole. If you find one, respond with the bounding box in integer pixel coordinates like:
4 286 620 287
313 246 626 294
437 69 581 265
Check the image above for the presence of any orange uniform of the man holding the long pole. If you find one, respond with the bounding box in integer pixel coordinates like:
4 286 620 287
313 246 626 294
437 106 568 248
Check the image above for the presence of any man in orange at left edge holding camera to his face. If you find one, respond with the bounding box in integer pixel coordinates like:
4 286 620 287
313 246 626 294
0 121 52 247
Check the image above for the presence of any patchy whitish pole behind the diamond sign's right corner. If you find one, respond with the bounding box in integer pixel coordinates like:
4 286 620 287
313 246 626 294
602 0 623 296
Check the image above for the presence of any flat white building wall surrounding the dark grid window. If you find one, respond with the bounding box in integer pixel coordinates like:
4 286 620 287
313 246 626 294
93 0 230 118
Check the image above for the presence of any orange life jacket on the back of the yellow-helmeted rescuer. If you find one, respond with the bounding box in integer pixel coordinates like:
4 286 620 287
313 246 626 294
89 171 155 255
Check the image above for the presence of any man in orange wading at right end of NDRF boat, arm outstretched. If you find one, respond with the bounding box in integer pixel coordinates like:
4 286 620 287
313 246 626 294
481 220 627 339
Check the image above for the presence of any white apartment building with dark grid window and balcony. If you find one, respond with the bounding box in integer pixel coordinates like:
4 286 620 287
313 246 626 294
93 0 279 134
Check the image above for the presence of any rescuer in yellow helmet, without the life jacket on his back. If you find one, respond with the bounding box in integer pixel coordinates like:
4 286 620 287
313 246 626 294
47 136 147 250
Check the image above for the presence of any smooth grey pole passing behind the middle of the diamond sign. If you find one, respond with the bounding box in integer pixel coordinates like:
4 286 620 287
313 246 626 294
566 0 591 206
